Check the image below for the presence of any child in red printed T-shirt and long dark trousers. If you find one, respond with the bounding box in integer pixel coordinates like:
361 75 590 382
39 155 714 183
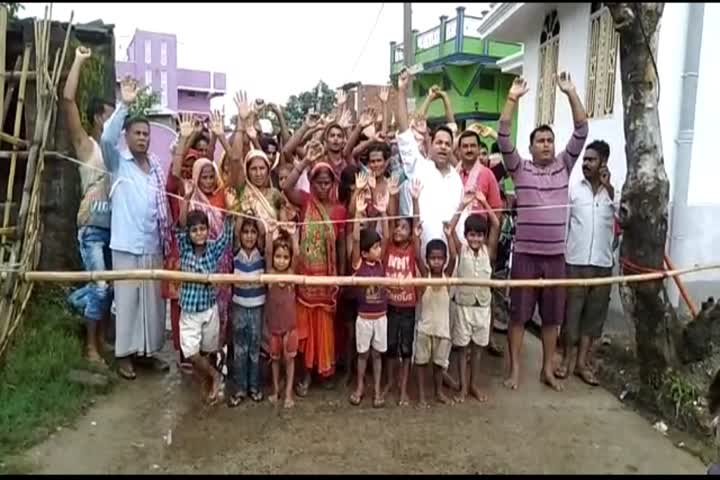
383 179 422 406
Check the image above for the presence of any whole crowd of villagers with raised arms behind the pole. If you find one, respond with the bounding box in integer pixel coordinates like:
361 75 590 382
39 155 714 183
63 47 614 407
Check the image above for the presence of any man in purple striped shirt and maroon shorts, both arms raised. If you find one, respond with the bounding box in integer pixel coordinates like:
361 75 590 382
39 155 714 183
497 72 588 391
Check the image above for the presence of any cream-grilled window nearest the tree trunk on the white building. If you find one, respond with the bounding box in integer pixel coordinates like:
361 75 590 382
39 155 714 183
585 2 620 118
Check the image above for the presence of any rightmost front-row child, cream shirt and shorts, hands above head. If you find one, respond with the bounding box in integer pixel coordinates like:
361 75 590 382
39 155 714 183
450 191 500 403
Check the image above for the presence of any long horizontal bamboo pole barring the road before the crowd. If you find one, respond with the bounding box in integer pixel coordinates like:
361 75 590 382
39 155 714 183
12 264 720 288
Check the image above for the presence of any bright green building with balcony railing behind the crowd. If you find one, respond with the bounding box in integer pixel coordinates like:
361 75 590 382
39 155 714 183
390 7 522 140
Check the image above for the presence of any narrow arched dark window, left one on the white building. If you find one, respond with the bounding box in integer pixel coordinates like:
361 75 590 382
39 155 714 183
535 10 560 125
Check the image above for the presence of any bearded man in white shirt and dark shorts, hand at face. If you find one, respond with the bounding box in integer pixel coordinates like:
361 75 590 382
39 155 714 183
555 140 615 386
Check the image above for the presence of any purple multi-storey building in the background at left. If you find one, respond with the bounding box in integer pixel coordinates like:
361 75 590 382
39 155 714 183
116 30 226 111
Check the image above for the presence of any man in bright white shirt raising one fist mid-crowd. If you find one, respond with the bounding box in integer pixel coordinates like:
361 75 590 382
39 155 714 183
397 70 463 251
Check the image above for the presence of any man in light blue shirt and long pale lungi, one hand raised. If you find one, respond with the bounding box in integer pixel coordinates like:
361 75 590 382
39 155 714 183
101 78 171 380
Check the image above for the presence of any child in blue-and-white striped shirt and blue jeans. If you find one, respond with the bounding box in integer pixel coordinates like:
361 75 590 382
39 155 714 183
228 216 265 407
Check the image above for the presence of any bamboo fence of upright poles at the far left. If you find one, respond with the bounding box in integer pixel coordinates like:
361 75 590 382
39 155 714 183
0 4 73 355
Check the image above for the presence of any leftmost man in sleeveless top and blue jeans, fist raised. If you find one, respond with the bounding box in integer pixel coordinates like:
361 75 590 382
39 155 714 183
63 47 115 366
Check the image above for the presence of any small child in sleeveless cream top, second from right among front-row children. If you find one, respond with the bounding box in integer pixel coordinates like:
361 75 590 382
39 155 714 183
414 217 456 407
